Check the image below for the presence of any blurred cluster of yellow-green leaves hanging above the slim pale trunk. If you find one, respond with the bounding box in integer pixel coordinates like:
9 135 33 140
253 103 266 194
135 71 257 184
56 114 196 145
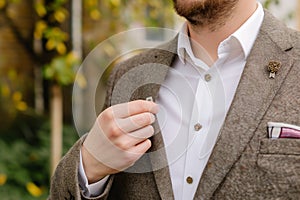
33 0 81 85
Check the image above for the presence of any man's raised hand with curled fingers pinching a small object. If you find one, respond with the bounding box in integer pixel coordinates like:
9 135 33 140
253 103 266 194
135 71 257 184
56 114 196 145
81 100 158 183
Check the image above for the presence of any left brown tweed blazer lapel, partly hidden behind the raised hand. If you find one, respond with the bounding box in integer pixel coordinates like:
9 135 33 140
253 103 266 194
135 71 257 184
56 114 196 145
131 37 177 199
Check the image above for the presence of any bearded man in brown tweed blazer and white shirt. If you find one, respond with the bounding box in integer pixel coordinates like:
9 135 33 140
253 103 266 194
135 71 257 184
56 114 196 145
50 0 300 199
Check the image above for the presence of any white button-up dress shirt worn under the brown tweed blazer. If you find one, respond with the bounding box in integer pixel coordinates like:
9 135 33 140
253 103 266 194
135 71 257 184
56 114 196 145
79 3 264 200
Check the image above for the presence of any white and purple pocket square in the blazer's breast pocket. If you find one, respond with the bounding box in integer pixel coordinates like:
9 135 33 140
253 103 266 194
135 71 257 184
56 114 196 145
268 122 300 139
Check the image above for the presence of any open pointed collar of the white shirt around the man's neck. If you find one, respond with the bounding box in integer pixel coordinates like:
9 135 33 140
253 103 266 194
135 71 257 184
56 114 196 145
177 2 264 63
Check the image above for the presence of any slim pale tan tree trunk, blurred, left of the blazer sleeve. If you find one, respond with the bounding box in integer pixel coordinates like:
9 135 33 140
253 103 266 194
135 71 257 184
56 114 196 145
50 84 63 175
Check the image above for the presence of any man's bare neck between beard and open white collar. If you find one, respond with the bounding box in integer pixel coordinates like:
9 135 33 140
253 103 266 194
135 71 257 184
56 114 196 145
188 0 257 62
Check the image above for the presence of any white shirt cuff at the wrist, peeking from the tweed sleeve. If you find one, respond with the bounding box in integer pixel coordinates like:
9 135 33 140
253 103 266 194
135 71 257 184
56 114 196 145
78 150 109 197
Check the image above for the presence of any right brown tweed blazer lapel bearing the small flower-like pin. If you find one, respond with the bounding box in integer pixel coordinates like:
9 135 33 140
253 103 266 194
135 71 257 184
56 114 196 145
195 11 292 199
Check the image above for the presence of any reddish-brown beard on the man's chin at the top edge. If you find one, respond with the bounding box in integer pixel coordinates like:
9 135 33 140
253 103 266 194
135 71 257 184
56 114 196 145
173 0 239 31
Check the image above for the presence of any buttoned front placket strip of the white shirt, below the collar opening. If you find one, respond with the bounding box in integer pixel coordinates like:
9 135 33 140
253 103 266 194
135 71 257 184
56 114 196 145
182 69 212 199
